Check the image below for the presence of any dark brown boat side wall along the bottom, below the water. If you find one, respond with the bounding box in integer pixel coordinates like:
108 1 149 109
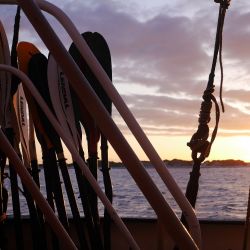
1 218 244 250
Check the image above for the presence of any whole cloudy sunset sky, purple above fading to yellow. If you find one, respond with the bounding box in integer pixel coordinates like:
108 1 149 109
0 0 250 161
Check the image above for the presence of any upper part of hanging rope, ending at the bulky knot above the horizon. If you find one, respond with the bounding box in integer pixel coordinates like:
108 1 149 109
187 0 230 163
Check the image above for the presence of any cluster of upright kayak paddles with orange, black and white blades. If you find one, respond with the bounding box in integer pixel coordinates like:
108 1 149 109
0 6 112 250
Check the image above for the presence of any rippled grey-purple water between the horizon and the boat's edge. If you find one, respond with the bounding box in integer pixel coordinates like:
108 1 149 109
3 167 250 220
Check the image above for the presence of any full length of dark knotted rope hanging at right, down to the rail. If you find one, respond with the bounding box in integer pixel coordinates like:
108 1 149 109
174 0 230 242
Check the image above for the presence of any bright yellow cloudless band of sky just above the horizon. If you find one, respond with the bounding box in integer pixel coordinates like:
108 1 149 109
37 136 250 163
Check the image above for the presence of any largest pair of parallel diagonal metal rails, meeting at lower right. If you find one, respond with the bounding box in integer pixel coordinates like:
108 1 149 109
0 0 201 249
